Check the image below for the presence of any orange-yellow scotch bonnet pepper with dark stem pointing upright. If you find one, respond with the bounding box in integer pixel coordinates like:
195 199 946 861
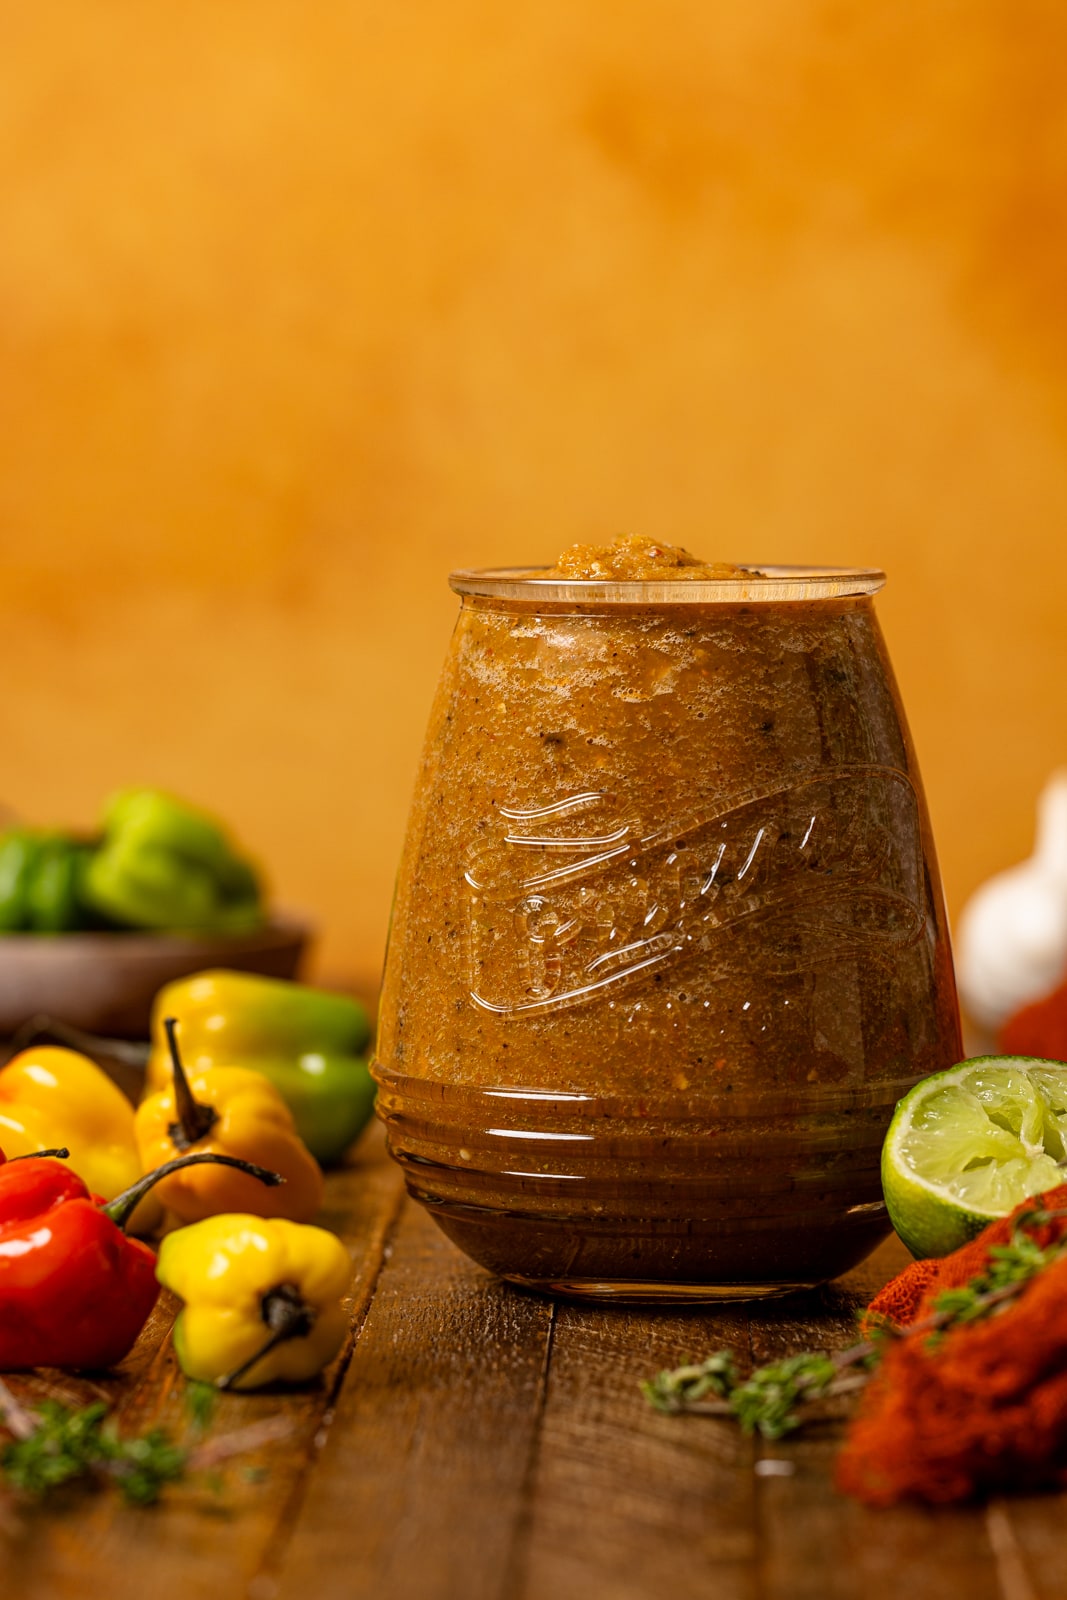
134 1018 323 1222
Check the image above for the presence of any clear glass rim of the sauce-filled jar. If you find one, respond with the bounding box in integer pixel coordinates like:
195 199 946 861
448 565 886 605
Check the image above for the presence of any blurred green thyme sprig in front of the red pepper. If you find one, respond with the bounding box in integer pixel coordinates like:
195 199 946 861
0 1379 290 1506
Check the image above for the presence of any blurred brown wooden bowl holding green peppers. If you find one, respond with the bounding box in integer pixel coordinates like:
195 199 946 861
0 918 310 1038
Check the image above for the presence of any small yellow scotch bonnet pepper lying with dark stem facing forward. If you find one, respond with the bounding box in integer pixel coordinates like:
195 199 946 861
155 1216 352 1389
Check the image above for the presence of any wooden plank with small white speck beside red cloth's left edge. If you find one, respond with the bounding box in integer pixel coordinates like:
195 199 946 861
752 1240 1021 1600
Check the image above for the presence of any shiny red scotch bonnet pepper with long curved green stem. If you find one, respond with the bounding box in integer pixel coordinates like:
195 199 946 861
0 1150 282 1371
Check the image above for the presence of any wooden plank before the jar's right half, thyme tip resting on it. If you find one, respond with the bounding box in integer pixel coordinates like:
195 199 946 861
515 1304 758 1600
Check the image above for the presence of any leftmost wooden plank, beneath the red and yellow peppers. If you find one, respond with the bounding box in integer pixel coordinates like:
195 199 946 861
0 1130 402 1600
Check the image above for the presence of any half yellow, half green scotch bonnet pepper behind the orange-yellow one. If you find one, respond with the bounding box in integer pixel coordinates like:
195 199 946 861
149 970 374 1166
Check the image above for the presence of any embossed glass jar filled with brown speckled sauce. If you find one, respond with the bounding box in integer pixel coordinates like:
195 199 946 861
374 566 961 1299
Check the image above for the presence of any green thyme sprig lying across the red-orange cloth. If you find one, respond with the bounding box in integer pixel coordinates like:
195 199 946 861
640 1206 1067 1440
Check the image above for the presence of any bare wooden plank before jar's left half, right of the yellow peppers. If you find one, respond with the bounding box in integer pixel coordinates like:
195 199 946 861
271 1206 552 1600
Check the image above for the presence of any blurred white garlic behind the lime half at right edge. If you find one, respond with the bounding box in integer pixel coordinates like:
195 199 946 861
957 768 1067 1030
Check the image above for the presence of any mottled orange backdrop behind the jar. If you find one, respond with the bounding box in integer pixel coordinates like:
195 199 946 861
0 0 1067 986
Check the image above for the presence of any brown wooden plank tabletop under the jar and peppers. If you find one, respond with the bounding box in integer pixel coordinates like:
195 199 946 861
0 1130 1067 1600
